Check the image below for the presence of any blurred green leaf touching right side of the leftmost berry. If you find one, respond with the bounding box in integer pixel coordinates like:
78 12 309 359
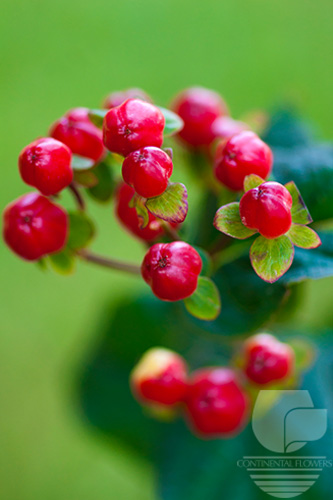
67 212 95 250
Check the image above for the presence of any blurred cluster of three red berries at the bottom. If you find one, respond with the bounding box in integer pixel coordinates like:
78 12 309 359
130 334 294 438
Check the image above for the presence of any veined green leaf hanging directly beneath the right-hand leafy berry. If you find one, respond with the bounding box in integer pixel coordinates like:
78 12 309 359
250 235 294 283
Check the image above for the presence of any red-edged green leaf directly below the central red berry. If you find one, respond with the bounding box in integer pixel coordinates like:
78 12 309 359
146 182 188 223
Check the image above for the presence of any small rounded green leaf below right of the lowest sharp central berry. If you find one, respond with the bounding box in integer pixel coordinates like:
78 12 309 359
184 276 221 321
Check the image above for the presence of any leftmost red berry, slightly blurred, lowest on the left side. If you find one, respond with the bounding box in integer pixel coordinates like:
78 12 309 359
3 193 68 260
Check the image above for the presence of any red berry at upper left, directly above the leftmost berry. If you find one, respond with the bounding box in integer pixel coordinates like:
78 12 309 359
19 137 73 196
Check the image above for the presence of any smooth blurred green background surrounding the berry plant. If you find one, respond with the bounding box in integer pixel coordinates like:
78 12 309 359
0 0 333 500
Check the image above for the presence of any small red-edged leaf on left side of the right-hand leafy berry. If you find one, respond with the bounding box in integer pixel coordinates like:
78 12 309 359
214 202 255 240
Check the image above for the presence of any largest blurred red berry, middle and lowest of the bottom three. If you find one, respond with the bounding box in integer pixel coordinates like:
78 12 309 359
185 367 248 438
